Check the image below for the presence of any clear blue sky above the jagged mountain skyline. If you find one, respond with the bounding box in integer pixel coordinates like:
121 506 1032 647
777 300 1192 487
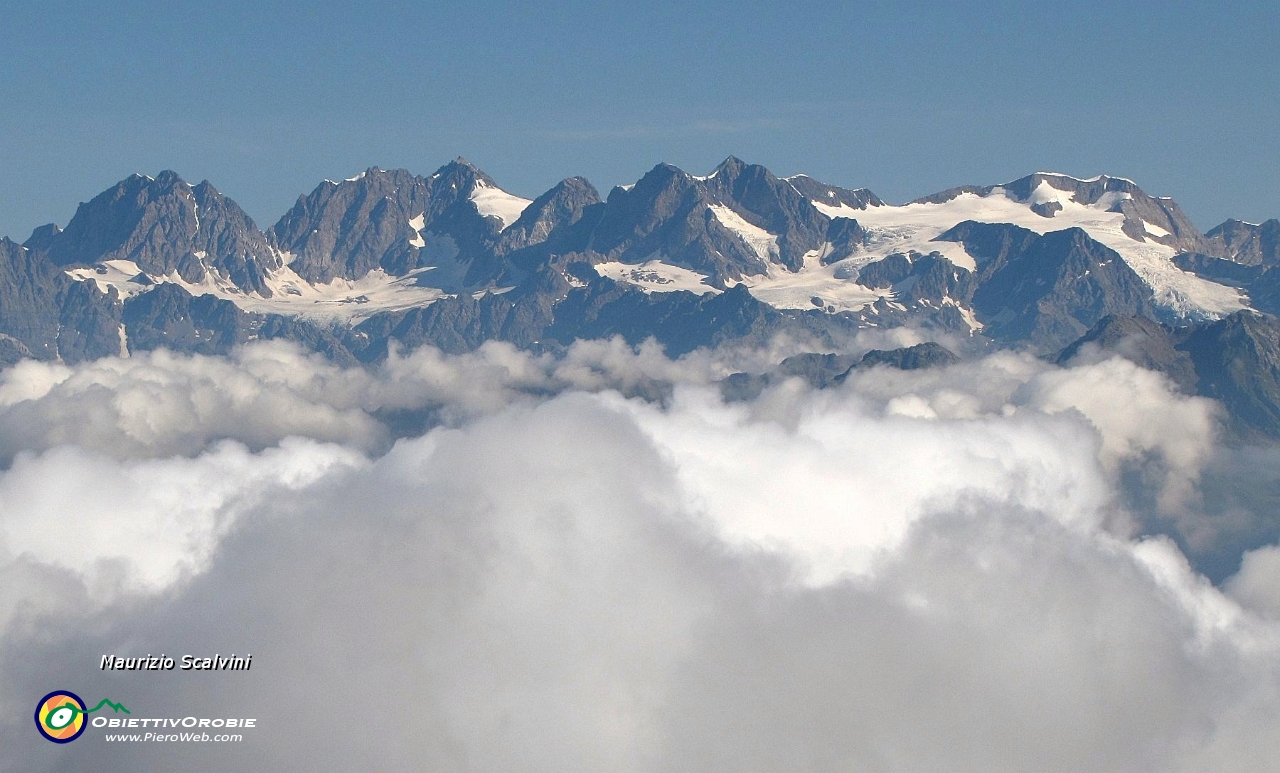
0 0 1280 241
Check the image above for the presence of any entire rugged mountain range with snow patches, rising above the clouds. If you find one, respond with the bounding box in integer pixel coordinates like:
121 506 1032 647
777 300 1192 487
0 157 1280 436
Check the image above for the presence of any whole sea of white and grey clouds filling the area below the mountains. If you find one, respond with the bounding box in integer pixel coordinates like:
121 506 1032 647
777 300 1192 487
0 334 1280 773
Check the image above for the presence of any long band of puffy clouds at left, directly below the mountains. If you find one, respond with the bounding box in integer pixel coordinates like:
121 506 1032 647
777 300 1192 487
0 339 796 462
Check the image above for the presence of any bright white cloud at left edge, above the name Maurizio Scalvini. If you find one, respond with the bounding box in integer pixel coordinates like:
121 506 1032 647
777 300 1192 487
0 439 362 596
